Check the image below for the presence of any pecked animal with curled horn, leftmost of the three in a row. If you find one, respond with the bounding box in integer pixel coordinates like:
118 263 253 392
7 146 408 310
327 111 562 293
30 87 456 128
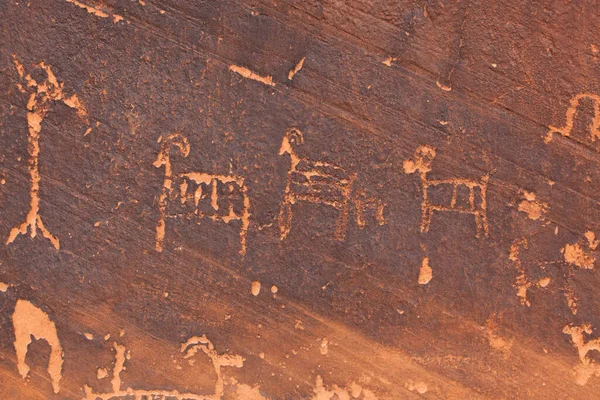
154 133 250 255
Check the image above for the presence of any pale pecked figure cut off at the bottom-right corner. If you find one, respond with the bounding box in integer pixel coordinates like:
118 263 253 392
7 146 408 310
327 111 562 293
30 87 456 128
563 324 600 386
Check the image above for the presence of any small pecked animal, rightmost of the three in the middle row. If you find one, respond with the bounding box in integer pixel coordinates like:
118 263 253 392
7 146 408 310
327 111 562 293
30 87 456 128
403 146 489 237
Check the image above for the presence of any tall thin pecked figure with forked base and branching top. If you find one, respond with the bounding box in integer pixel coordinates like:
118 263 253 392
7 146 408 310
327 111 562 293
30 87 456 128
6 56 89 250
